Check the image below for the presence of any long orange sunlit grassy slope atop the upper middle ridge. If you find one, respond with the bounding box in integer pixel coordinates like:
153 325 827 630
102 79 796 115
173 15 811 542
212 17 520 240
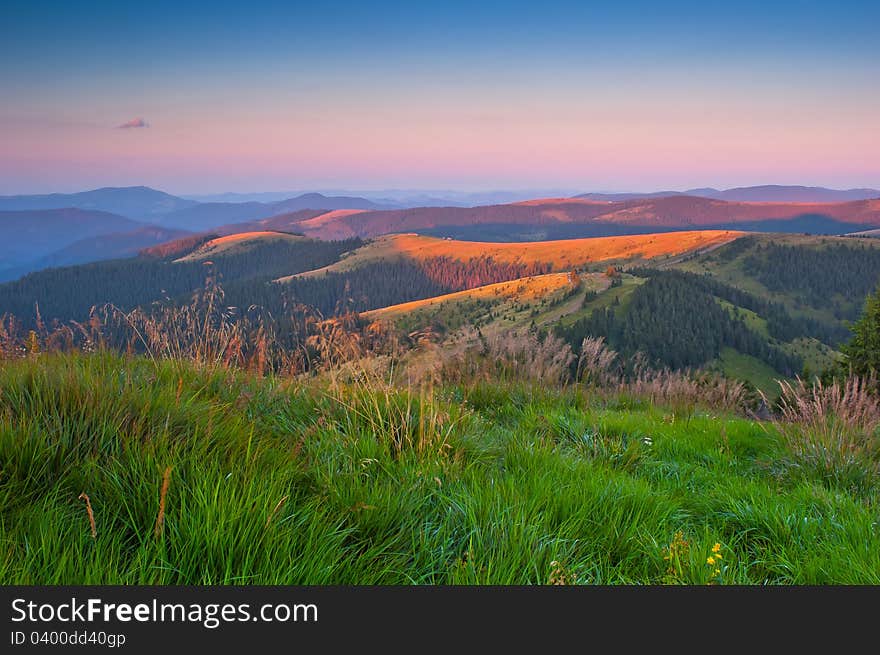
278 230 744 282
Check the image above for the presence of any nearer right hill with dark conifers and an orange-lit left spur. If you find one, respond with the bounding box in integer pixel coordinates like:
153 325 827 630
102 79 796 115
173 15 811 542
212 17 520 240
346 232 880 397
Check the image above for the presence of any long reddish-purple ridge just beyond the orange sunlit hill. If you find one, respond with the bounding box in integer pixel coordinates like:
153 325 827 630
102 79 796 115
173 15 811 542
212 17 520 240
248 196 880 246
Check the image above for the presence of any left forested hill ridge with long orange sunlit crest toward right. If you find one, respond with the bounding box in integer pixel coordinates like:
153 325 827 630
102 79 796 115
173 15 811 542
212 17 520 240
0 231 738 334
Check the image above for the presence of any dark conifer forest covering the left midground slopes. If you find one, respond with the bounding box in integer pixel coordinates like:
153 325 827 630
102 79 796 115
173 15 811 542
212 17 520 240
0 239 551 338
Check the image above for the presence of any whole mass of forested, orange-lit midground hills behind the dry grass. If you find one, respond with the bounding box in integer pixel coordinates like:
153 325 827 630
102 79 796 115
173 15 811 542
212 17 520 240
0 226 880 391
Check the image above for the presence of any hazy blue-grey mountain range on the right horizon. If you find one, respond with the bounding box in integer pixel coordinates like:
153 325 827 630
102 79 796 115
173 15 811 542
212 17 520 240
575 184 880 202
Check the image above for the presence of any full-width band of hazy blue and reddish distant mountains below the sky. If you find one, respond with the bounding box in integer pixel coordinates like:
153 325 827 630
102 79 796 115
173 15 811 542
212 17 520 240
0 186 880 280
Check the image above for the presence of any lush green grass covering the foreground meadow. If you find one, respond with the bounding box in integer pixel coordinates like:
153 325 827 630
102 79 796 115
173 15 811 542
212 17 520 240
0 354 880 584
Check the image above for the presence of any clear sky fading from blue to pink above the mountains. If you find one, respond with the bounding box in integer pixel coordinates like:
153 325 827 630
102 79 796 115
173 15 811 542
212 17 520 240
0 0 880 195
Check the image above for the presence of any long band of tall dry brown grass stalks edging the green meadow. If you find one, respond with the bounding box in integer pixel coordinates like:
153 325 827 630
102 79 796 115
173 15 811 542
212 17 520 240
0 269 764 420
